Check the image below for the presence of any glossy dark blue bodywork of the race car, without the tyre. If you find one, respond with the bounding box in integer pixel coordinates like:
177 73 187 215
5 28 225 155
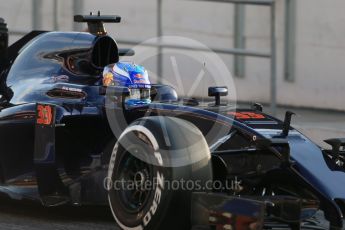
0 19 345 228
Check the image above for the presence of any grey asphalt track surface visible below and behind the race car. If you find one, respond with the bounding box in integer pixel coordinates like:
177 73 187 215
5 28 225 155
0 105 345 230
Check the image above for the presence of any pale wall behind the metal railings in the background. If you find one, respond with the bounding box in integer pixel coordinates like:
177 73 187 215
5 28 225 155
0 0 345 111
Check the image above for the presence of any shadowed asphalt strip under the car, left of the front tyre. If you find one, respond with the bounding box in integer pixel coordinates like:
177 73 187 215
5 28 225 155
0 197 119 230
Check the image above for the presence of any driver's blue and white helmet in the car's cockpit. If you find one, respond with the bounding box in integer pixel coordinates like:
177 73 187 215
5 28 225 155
103 62 151 106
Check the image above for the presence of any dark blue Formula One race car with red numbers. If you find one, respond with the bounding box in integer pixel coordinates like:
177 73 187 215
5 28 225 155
0 15 345 230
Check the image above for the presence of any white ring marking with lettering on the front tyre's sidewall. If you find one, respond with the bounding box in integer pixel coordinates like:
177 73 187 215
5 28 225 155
107 125 164 230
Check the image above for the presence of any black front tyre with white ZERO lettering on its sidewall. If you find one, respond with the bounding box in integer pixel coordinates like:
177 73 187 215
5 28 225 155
107 116 212 230
